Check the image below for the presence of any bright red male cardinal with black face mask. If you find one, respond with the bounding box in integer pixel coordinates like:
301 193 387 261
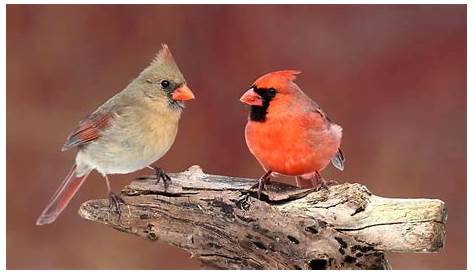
240 70 344 196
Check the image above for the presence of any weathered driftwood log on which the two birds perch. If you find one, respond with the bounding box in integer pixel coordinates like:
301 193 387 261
79 166 447 269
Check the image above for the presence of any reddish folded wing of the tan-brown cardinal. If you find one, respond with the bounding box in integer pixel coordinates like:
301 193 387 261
61 113 113 151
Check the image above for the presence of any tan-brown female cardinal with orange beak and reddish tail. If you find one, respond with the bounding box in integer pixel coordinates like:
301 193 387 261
36 45 194 225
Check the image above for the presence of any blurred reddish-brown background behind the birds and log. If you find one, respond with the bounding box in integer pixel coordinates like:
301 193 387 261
7 5 467 269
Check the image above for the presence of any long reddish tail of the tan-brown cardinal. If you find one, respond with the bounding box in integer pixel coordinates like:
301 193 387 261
36 165 90 225
